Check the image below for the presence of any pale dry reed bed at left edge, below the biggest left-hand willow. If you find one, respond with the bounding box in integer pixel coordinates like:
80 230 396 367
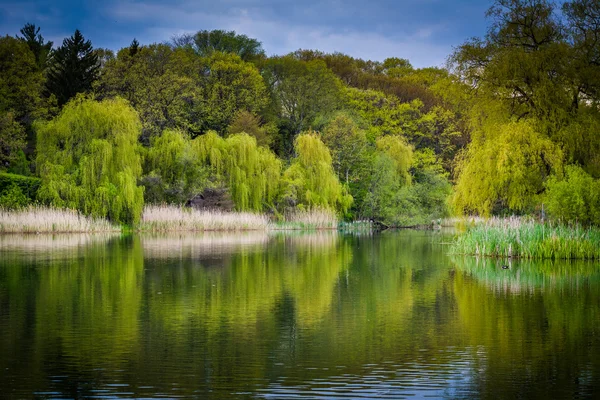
0 206 121 233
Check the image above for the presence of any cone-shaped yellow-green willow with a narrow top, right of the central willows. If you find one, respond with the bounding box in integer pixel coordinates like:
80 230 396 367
281 131 352 212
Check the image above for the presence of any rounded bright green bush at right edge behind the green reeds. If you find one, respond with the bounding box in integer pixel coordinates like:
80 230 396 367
544 165 600 225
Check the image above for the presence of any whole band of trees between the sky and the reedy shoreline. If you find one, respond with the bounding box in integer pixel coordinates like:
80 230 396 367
0 0 600 226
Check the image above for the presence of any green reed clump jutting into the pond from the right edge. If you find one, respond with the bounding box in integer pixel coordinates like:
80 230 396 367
450 217 600 260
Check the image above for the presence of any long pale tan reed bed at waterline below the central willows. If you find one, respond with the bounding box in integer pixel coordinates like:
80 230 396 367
138 205 270 232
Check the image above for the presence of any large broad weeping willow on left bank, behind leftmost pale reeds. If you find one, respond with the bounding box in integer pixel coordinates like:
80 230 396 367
36 97 144 223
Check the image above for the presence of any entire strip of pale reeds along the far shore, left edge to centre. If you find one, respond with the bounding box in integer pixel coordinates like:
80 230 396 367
0 205 373 234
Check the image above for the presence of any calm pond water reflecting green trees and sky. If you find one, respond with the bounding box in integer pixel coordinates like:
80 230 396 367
0 231 600 399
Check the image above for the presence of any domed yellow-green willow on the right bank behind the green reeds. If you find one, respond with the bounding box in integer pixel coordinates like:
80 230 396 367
452 120 563 215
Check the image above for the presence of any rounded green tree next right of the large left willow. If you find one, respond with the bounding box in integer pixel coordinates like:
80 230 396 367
142 130 208 204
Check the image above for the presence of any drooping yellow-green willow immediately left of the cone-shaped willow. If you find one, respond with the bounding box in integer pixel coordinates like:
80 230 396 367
192 131 281 211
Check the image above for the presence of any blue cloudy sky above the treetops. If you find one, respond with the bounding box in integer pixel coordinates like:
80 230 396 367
0 0 492 68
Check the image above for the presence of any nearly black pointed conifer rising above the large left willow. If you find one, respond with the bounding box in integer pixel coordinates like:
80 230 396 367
46 30 100 105
